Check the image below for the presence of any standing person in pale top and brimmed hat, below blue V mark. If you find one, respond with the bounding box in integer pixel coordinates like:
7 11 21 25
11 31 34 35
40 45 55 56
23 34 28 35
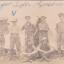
10 19 21 56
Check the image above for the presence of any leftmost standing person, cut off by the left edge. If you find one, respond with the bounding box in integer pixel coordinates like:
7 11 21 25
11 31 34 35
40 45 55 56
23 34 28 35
0 18 8 54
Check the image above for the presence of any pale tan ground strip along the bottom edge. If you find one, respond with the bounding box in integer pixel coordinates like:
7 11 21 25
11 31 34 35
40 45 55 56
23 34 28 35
0 53 64 64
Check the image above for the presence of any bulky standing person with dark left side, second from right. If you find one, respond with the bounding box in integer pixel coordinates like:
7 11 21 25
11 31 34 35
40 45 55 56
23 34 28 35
34 16 50 61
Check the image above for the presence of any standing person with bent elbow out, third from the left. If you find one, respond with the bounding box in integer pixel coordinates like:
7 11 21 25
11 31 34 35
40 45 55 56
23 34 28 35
22 16 35 53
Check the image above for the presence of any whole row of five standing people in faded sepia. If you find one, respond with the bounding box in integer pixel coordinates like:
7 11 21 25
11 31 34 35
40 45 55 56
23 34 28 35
0 13 64 60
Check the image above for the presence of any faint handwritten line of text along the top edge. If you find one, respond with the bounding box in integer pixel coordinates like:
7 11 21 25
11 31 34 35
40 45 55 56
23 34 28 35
0 1 64 8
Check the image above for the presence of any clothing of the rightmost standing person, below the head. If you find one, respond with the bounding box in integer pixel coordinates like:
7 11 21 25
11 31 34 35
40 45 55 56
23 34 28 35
56 22 64 50
